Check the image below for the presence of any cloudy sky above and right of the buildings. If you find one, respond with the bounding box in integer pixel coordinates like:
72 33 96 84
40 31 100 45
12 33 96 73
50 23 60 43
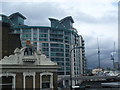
0 0 118 68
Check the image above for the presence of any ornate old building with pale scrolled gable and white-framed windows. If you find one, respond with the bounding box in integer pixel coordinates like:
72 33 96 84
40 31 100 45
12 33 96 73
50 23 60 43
0 47 59 90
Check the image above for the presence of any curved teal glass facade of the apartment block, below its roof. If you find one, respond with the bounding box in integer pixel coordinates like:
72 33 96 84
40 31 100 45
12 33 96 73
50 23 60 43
20 27 80 75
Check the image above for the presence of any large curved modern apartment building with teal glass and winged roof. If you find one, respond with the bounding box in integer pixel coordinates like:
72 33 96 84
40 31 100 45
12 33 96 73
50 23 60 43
0 12 86 75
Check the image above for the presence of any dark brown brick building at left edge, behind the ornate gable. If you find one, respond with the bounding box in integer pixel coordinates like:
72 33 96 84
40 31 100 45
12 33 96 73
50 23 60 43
0 15 21 59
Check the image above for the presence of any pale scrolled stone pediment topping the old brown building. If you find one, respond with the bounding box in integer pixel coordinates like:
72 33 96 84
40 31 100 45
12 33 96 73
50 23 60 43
0 47 57 65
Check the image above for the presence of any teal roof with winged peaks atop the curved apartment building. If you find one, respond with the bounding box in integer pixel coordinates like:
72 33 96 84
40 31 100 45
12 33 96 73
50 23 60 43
0 12 77 33
